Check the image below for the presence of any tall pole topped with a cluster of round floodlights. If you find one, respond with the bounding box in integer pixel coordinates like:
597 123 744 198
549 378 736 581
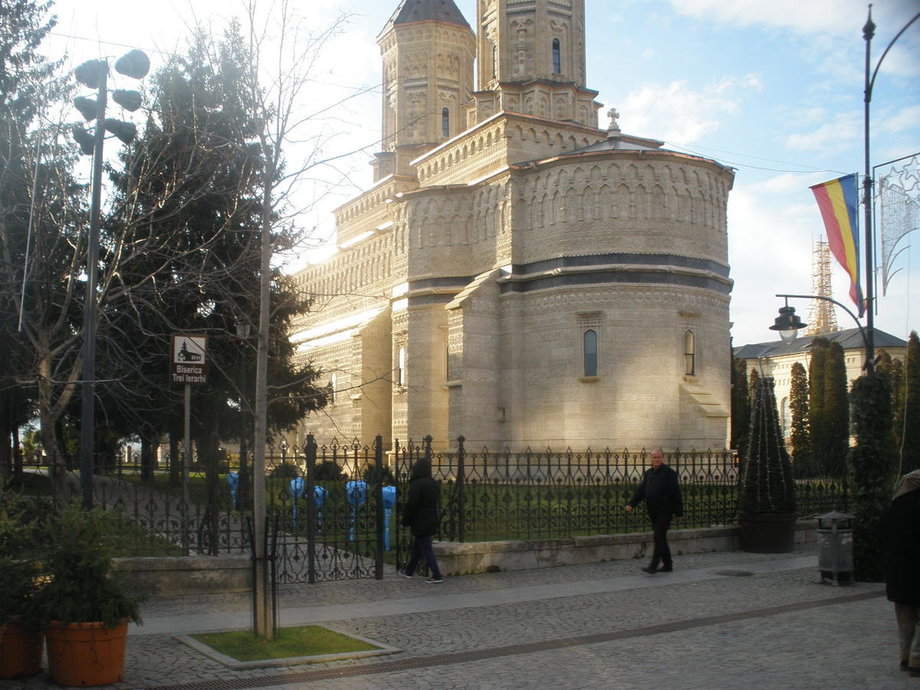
72 50 150 509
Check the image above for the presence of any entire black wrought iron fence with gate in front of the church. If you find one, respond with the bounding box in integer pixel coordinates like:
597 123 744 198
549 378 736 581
16 437 847 560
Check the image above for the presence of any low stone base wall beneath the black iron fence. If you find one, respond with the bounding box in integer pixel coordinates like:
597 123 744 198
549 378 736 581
115 520 817 598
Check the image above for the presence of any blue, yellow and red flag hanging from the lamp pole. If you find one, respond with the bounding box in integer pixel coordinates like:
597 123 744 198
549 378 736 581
810 174 863 316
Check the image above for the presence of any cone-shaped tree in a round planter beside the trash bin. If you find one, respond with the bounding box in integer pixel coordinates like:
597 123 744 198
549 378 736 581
738 377 796 553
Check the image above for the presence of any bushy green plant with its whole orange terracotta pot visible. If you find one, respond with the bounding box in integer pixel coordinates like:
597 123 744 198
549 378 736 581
35 508 140 686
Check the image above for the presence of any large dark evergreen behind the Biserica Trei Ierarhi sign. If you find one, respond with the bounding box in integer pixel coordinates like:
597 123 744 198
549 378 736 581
106 23 325 487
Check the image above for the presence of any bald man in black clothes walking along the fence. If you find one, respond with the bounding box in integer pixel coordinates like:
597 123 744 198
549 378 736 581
626 448 684 575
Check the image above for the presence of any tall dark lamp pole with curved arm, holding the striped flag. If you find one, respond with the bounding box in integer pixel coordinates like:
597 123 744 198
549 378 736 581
863 4 920 373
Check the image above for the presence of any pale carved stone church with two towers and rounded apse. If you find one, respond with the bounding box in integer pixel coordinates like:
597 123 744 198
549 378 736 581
292 0 734 452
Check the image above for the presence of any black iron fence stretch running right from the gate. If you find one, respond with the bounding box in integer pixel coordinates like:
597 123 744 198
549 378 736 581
396 437 845 541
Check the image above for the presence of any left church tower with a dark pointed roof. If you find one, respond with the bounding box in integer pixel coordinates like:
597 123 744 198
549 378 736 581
374 0 476 180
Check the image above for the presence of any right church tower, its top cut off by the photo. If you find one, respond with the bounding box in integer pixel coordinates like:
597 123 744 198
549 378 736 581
467 0 600 127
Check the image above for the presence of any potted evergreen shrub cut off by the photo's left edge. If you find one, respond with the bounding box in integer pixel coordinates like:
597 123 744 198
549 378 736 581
0 486 42 679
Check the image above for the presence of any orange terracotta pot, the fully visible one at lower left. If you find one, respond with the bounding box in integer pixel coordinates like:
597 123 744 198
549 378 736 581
45 620 128 686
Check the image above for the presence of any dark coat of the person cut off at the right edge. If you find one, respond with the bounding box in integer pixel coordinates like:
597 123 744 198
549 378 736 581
882 490 920 606
